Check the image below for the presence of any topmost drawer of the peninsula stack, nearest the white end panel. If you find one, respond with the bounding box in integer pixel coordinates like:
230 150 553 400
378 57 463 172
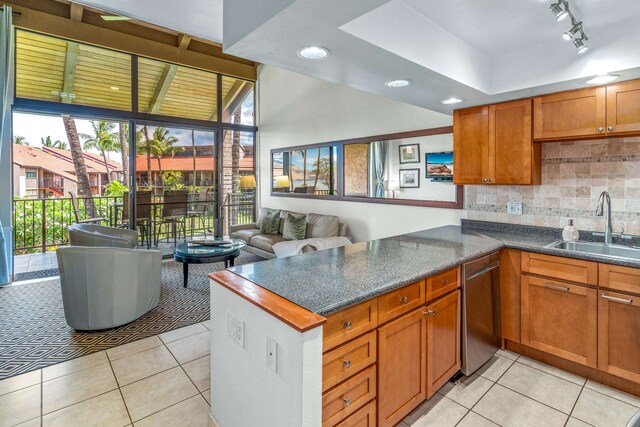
322 298 378 351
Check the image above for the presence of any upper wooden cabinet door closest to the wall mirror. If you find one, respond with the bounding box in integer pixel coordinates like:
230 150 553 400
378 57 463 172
453 106 489 184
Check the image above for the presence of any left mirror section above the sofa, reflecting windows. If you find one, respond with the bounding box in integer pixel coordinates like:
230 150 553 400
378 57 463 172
271 145 338 196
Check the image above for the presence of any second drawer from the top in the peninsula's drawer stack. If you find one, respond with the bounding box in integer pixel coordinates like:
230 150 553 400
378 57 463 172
322 331 376 391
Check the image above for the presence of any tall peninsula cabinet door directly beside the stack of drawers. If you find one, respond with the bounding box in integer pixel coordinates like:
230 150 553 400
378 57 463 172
378 307 427 427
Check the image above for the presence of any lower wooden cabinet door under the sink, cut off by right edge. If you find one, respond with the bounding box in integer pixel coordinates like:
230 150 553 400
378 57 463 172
598 291 640 383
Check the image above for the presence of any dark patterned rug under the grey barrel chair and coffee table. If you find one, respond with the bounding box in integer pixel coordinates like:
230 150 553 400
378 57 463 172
0 252 262 379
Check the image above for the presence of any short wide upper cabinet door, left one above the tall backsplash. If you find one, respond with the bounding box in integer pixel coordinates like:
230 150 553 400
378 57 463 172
533 87 607 140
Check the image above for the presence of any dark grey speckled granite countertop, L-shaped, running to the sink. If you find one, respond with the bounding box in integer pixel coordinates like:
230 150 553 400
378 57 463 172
229 221 640 316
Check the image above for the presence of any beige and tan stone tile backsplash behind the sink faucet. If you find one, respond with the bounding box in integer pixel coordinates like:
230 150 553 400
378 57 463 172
465 137 640 235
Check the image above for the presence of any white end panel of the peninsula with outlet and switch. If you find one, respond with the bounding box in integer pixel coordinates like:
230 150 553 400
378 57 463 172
211 281 322 427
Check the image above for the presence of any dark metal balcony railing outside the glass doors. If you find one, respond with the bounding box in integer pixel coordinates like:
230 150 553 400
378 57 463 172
13 193 255 255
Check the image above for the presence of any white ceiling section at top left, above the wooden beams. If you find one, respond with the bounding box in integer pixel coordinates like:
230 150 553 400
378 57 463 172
73 0 222 43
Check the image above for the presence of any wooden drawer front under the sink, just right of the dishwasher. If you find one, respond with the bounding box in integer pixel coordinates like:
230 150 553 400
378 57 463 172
522 252 598 286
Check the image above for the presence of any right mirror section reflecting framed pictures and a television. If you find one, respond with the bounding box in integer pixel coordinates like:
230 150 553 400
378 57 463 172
344 134 457 202
